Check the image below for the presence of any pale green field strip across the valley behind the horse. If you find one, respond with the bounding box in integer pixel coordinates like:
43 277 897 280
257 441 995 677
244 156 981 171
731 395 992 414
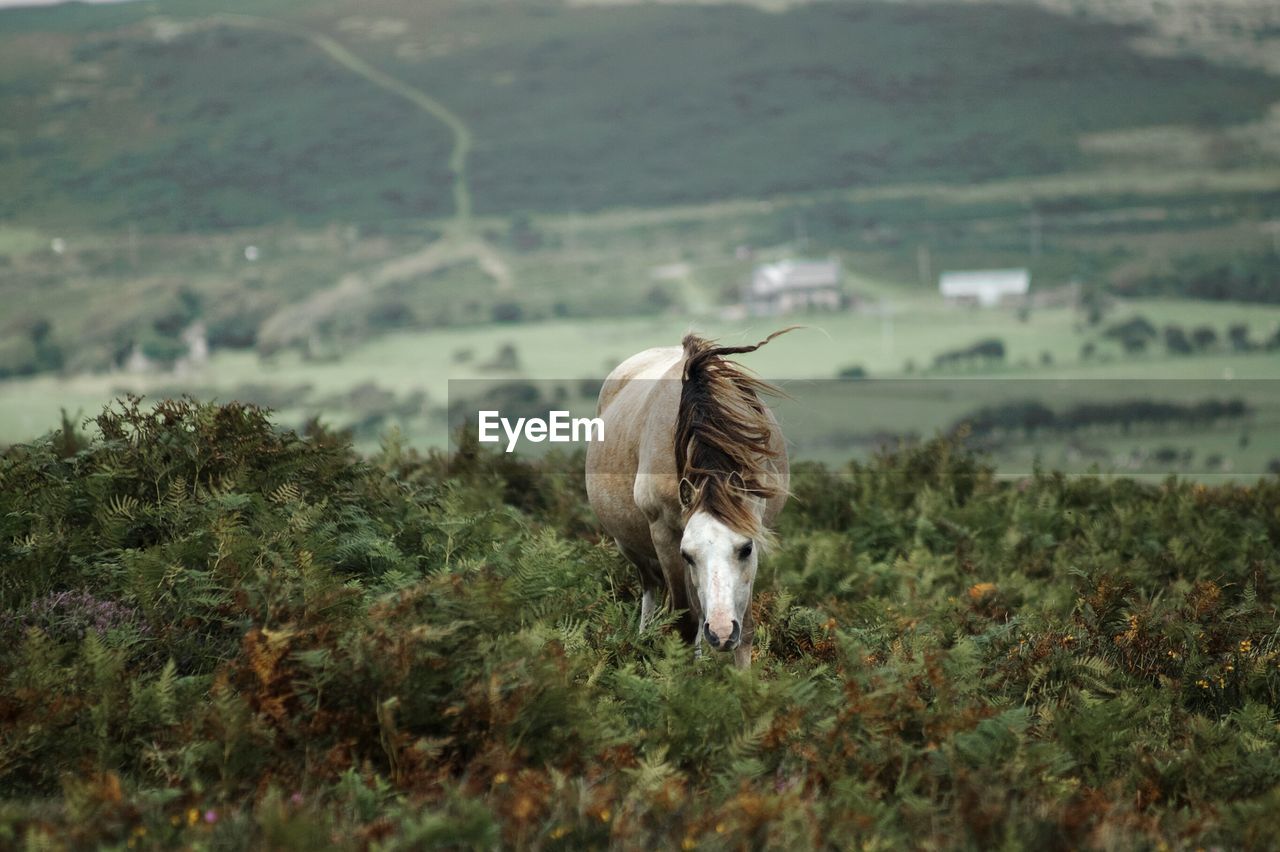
0 297 1280 477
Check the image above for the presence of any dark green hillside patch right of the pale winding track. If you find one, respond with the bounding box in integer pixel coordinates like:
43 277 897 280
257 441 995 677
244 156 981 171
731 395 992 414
398 4 1280 211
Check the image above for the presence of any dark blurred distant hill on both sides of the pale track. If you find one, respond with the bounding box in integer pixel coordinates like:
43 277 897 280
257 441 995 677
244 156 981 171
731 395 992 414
0 0 1280 230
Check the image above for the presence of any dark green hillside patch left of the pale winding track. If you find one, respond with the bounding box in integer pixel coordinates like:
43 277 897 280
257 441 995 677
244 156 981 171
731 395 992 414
3 28 449 230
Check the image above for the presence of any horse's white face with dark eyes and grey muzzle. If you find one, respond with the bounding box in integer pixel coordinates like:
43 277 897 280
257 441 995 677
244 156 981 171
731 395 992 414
680 470 764 651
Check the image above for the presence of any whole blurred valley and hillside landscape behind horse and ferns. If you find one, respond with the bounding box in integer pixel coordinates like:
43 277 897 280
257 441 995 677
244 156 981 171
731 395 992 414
0 0 1280 480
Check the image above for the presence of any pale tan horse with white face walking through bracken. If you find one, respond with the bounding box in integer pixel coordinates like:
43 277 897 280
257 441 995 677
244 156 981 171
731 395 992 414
586 329 792 668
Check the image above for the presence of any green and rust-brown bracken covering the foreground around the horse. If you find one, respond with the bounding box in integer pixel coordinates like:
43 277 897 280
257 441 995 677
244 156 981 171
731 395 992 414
0 399 1280 849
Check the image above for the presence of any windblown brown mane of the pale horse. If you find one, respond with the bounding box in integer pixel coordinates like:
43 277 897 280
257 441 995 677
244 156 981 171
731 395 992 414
676 326 795 544
